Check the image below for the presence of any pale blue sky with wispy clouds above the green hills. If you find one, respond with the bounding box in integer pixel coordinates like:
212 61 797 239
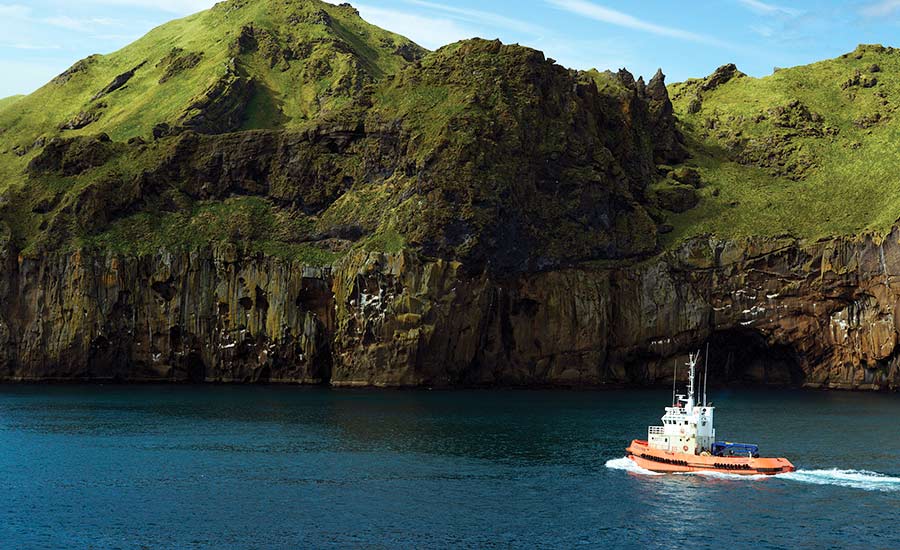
0 0 900 97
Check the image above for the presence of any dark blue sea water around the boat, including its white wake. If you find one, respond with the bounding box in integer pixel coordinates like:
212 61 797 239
0 386 900 549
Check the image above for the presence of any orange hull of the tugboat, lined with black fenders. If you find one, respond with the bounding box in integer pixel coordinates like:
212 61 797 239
625 439 795 475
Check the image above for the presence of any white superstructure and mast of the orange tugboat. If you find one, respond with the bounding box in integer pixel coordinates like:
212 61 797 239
647 353 716 454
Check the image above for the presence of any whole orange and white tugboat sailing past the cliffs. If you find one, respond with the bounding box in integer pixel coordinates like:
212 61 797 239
626 353 795 475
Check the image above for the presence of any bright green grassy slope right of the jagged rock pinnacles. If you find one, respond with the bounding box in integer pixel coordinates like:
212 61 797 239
668 46 900 242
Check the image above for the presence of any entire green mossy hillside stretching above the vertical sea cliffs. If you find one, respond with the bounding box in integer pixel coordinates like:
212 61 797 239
7 0 900 272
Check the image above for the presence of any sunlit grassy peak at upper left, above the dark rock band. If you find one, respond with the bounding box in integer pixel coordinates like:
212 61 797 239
0 0 424 190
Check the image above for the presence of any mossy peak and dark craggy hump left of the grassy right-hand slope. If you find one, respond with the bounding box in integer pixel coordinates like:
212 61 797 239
0 0 684 272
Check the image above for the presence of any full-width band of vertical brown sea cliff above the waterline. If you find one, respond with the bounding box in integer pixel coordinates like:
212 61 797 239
0 230 900 389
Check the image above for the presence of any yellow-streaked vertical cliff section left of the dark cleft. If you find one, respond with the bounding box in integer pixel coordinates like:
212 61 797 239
0 247 334 383
